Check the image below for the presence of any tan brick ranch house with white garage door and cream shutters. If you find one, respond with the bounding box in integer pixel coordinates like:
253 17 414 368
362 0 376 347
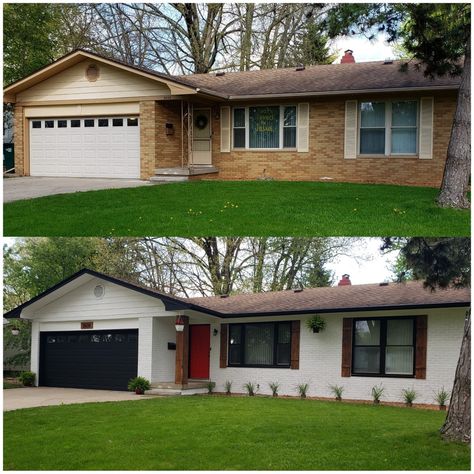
4 50 459 186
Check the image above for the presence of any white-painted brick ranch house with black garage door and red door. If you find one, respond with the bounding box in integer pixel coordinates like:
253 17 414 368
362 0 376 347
5 269 470 403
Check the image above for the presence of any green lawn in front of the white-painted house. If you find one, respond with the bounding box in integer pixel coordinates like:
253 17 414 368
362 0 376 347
3 396 470 470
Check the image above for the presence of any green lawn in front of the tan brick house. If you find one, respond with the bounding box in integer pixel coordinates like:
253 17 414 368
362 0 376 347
4 181 470 237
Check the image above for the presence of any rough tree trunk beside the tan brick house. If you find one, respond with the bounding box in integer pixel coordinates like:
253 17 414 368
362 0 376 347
438 46 471 208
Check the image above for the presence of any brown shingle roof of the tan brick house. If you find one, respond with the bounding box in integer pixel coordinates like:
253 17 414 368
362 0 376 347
177 61 460 98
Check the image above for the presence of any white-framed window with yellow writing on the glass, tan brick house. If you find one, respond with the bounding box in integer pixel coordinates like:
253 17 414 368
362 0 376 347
232 105 297 149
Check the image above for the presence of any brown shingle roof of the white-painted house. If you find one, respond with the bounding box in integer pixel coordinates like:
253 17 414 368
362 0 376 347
185 282 471 315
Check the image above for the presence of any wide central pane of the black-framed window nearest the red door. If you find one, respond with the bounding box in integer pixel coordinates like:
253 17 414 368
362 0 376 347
245 324 274 365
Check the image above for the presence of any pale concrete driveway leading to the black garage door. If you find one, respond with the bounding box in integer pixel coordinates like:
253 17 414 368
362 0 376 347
3 387 152 411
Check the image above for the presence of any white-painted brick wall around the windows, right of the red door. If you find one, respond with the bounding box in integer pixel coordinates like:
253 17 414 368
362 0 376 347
211 309 465 403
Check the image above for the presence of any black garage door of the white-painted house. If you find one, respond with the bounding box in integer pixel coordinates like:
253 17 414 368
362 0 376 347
39 329 138 390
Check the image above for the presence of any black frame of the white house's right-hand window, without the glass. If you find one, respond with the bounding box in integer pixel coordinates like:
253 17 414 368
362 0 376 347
351 316 417 379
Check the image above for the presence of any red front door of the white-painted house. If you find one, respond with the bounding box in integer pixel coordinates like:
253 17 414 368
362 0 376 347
189 324 211 379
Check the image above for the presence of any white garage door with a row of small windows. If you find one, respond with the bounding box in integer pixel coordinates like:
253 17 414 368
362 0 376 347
30 117 140 178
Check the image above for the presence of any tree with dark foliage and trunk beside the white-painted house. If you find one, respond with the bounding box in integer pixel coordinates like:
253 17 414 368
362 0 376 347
382 237 471 442
